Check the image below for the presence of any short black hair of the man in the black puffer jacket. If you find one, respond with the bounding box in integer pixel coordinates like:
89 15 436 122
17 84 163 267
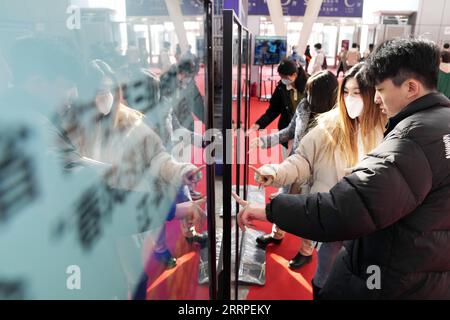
364 39 440 89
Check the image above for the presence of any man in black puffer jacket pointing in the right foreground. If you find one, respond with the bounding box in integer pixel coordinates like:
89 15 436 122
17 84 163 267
234 39 450 299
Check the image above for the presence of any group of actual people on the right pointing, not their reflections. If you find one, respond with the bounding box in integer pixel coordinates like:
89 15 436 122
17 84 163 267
233 39 450 299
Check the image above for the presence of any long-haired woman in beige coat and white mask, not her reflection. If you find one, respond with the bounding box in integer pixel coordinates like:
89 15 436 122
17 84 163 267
250 64 386 299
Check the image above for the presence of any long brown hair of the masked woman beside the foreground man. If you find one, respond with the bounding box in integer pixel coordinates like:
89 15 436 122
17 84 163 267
319 63 387 166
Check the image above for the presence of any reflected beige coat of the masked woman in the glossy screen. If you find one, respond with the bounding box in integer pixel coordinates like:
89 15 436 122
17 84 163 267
67 104 197 191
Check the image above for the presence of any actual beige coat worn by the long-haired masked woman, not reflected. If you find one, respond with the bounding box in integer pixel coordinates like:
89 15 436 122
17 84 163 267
260 109 383 193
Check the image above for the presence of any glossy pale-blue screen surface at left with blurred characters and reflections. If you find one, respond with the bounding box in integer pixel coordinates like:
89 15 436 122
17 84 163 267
0 0 209 299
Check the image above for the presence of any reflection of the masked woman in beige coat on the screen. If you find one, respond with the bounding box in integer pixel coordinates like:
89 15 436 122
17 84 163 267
66 60 197 190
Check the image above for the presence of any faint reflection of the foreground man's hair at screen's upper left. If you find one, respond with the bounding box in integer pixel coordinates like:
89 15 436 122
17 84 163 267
9 37 84 85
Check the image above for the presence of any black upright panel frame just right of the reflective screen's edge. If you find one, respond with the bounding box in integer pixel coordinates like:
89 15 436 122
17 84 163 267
219 10 251 300
